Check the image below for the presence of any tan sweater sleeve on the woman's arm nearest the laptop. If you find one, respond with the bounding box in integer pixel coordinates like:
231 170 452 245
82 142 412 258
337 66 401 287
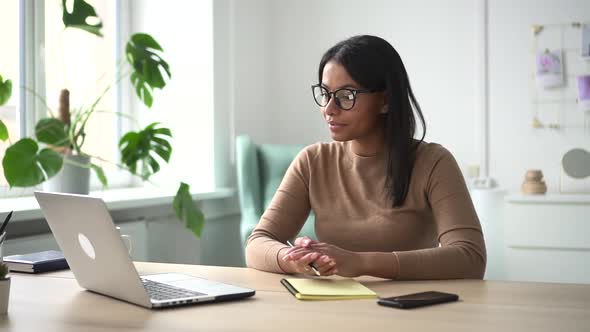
245 147 311 273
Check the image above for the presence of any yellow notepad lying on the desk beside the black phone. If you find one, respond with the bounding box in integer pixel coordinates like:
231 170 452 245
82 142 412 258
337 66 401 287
281 278 377 300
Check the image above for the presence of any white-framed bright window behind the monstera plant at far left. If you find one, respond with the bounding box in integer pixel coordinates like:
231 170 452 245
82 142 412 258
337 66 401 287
0 0 132 196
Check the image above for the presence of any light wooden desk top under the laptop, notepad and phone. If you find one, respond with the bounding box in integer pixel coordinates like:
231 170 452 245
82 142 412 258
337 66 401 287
0 263 590 332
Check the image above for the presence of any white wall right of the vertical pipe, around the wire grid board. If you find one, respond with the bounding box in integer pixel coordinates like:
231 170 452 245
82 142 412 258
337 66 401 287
490 0 590 191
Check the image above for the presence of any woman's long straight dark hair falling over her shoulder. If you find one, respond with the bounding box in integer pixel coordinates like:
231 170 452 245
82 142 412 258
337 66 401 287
318 35 426 207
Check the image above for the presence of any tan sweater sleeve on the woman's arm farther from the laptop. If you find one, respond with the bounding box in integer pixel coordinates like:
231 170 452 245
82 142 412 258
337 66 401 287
394 148 486 280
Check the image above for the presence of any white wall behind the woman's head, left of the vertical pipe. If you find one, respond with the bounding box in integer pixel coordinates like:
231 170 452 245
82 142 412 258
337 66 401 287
222 0 480 179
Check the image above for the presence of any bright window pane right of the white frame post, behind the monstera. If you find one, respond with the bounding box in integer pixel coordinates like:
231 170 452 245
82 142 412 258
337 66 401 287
44 0 120 171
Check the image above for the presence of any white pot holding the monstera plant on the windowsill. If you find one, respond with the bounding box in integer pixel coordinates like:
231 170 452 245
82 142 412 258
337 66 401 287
43 155 90 195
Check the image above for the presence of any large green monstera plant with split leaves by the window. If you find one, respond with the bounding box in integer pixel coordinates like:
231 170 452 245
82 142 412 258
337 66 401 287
0 0 204 236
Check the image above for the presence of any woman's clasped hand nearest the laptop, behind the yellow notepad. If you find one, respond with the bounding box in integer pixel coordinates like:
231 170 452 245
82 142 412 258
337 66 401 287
279 237 338 276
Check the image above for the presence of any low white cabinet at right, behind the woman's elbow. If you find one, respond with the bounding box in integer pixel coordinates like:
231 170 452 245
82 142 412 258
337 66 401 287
504 194 590 283
